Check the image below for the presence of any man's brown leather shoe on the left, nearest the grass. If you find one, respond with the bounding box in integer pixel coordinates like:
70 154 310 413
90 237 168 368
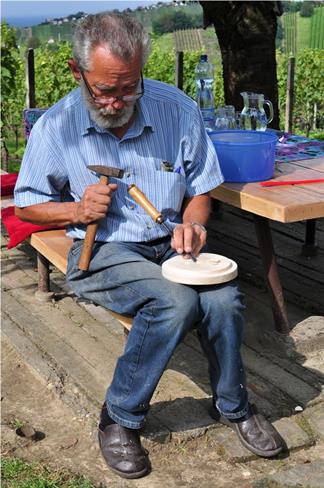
98 406 151 479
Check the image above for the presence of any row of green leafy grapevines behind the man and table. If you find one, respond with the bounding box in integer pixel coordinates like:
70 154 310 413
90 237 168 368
1 23 324 171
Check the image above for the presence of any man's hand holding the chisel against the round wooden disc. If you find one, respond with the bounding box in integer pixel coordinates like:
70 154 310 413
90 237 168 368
171 223 207 256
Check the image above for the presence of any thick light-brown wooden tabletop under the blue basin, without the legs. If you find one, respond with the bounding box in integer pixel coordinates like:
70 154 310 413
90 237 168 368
211 158 324 222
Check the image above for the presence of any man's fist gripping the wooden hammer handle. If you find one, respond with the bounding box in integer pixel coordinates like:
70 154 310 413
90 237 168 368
75 183 117 224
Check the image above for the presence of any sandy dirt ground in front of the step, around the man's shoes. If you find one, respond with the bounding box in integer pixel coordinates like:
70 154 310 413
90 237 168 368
1 341 324 488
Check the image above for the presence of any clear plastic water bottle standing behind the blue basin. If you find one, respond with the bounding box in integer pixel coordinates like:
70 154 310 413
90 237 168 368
195 54 215 130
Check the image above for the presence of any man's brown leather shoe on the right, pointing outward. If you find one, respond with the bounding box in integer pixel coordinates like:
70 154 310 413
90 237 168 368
209 404 286 457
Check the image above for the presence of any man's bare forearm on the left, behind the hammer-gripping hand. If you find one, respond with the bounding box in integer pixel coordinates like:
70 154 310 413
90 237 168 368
15 202 79 227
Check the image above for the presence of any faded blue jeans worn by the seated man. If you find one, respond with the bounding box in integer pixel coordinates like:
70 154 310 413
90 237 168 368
67 237 248 429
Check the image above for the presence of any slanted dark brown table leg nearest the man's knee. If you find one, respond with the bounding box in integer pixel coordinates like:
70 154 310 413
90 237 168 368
254 215 290 334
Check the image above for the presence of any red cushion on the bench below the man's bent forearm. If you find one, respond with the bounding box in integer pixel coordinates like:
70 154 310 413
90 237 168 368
1 206 63 249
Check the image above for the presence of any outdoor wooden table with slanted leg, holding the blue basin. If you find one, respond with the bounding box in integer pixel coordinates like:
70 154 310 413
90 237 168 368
211 157 324 334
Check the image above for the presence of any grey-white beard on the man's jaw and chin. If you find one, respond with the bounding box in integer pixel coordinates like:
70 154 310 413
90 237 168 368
81 83 135 129
